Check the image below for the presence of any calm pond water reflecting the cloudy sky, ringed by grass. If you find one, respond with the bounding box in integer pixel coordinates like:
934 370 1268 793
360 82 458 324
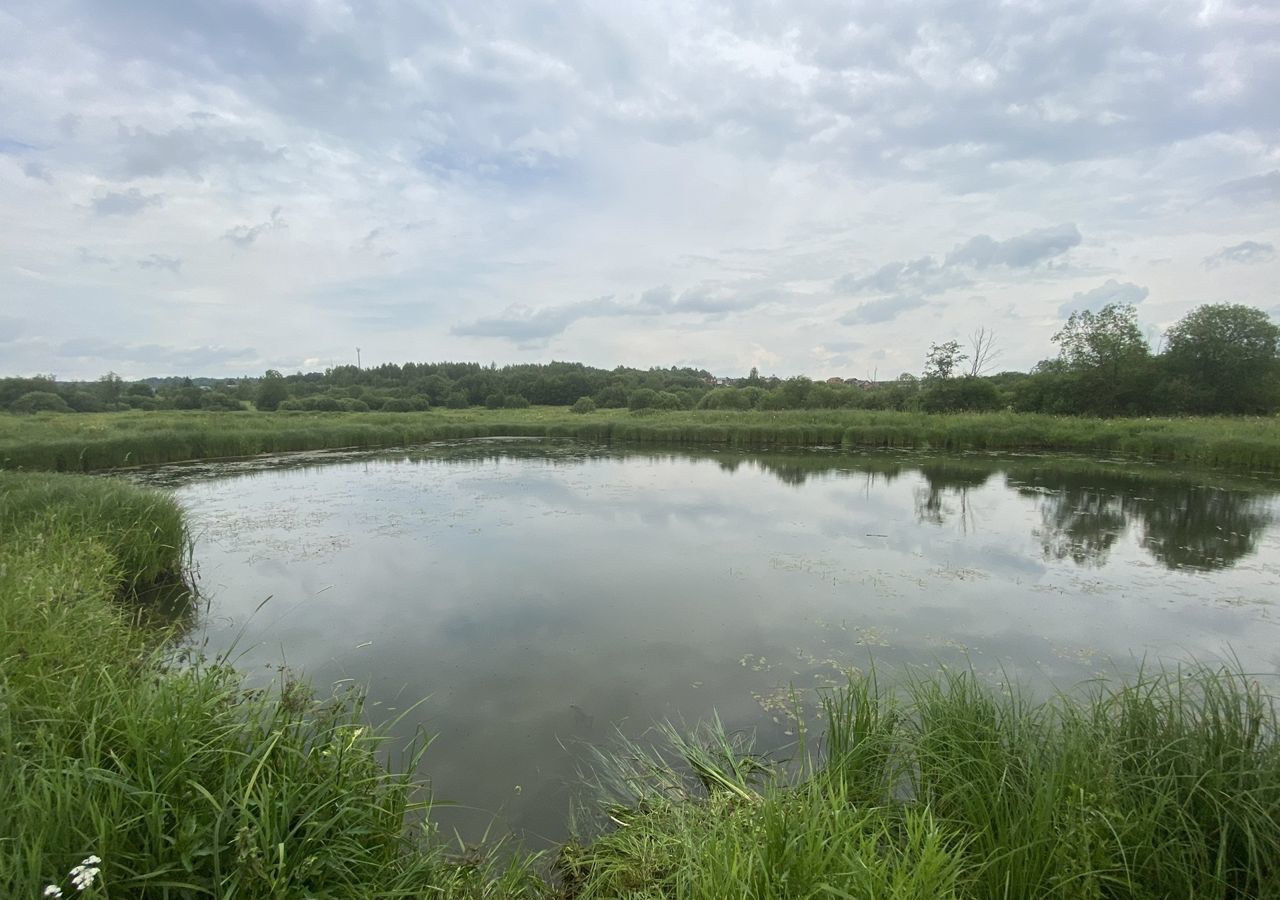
137 442 1280 845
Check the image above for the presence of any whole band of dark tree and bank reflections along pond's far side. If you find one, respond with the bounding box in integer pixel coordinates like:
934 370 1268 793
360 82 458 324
134 440 1274 570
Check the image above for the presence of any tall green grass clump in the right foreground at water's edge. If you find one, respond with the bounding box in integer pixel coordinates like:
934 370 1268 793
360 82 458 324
561 667 1280 900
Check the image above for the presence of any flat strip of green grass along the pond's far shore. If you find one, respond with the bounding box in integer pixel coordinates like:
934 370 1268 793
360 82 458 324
0 407 1280 471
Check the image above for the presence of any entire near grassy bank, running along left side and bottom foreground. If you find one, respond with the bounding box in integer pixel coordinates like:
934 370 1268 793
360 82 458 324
10 472 1280 900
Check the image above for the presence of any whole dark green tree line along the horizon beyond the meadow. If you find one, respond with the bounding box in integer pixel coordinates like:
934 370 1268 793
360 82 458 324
0 303 1280 416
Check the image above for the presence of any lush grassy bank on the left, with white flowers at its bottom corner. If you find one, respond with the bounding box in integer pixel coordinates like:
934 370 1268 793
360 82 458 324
0 474 540 897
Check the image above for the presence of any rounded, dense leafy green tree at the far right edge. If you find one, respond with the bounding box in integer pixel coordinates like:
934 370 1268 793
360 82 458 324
1161 303 1280 412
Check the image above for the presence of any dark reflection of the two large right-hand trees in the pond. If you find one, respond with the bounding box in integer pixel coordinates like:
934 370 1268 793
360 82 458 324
1020 472 1271 571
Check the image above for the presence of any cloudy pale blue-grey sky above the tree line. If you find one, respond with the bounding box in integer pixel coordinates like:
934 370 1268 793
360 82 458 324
0 0 1280 379
